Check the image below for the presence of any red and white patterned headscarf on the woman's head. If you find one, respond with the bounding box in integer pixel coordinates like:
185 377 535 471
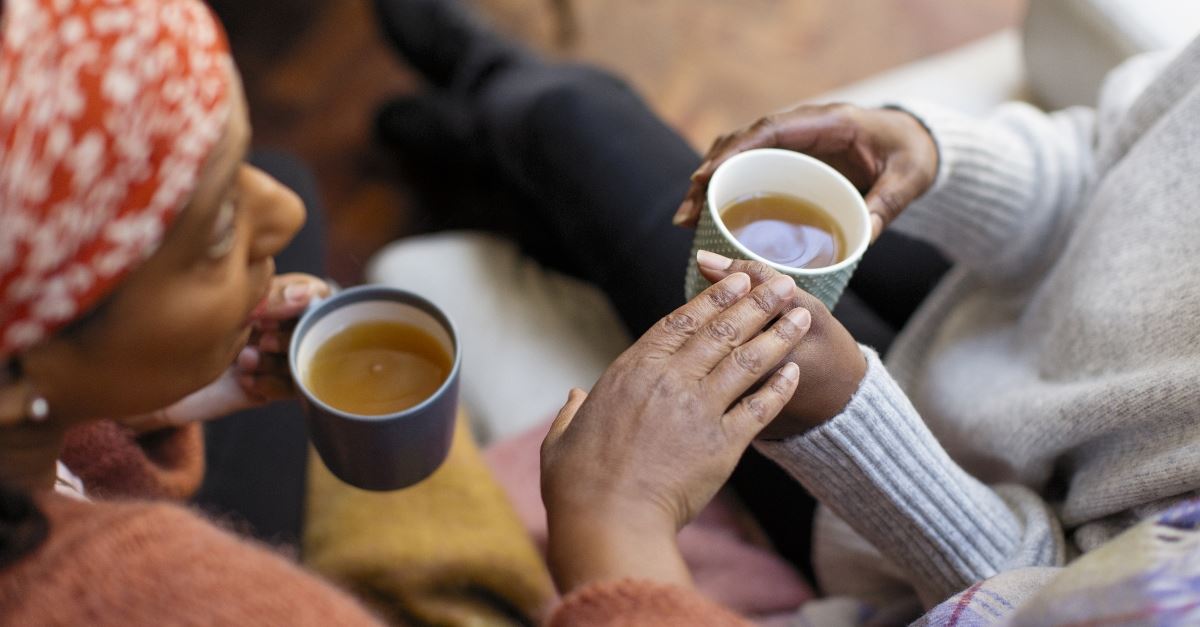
0 0 232 362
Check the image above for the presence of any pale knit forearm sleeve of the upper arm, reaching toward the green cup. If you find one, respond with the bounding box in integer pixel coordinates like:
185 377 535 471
894 102 1096 280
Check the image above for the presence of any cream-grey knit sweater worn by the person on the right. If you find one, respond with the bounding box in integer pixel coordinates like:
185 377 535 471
760 36 1200 619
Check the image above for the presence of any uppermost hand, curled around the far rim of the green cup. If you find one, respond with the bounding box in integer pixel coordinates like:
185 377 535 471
674 105 937 240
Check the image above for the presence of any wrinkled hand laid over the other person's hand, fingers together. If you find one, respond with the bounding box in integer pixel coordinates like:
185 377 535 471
541 273 810 593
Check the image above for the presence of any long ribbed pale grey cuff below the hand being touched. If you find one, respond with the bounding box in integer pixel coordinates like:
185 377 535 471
757 347 1021 603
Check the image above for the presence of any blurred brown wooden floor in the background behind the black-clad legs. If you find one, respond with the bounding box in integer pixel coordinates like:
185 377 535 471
212 0 1025 283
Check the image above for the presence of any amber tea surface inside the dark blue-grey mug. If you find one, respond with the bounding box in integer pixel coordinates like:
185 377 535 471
305 321 452 416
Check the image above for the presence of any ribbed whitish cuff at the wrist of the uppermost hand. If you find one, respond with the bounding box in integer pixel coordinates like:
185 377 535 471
890 102 1033 264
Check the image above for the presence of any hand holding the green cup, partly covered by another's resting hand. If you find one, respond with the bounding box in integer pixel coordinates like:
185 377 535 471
696 251 866 440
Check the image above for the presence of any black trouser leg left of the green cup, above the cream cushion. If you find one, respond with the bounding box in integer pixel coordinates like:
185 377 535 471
476 61 700 336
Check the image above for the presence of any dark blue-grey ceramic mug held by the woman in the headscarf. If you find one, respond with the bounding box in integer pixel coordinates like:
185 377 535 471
288 286 462 490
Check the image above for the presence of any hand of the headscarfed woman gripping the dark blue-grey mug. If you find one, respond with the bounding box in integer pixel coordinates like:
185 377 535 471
124 273 330 432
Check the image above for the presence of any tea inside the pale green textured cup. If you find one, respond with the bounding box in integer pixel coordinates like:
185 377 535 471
720 193 846 268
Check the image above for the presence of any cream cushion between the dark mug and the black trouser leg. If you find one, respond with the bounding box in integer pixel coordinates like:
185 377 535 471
366 232 630 444
